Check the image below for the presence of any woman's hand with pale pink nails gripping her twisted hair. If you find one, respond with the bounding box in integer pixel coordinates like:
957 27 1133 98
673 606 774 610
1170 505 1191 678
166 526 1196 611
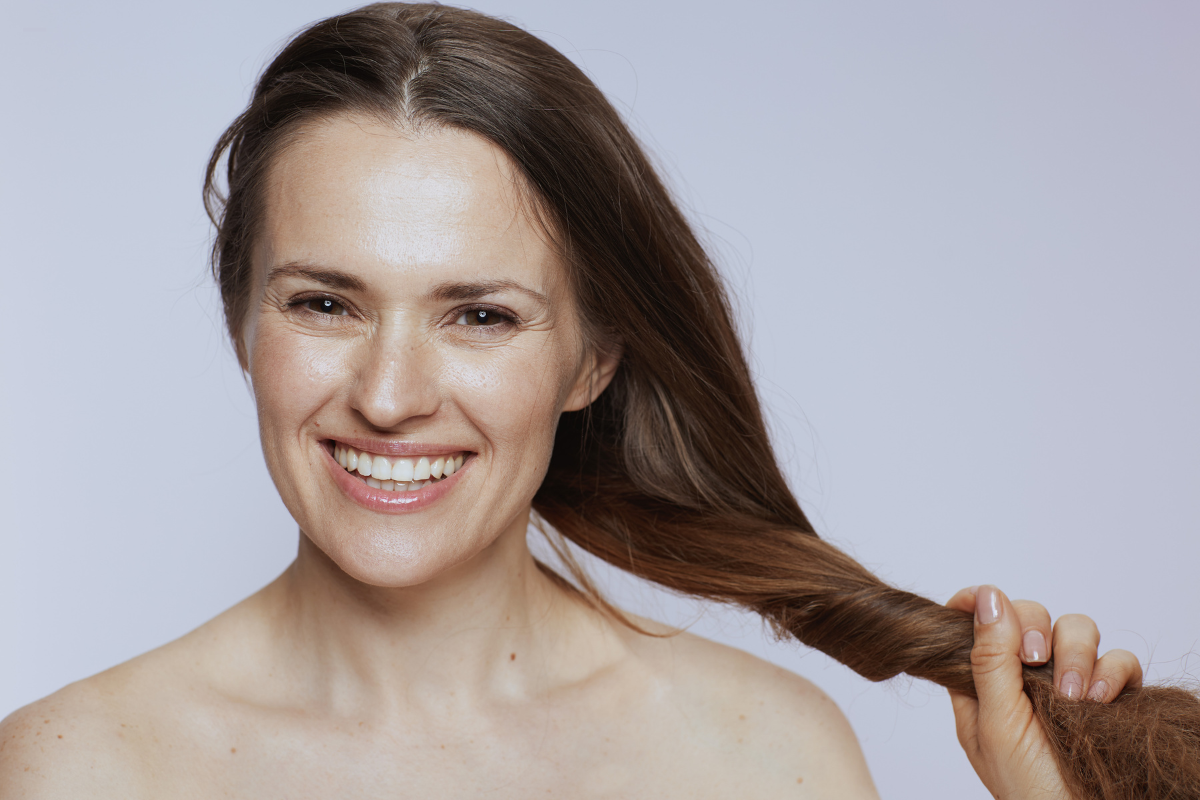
946 585 1141 800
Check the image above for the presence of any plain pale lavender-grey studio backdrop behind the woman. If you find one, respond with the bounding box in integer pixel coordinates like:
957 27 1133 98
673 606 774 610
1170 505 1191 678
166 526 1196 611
0 0 1200 798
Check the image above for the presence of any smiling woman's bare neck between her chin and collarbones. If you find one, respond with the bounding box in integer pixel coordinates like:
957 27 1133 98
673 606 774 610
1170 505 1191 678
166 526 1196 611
249 519 622 715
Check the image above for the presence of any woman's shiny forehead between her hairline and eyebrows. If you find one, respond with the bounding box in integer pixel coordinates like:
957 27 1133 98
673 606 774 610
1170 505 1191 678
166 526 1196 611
256 118 560 290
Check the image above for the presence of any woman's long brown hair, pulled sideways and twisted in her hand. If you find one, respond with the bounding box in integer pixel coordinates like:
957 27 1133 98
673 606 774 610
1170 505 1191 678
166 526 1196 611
205 4 1200 800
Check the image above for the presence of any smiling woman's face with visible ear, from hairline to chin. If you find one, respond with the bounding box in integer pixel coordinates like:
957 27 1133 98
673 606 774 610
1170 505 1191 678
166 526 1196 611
244 118 613 587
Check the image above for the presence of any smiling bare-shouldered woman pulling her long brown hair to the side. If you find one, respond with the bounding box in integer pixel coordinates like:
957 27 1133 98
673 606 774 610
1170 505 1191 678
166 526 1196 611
6 7 1200 796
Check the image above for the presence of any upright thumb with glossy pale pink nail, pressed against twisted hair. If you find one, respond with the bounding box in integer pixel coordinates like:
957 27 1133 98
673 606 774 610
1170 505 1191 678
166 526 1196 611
971 585 1028 721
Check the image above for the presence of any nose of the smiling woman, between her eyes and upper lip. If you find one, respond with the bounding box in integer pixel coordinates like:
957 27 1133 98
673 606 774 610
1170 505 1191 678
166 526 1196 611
350 325 438 429
